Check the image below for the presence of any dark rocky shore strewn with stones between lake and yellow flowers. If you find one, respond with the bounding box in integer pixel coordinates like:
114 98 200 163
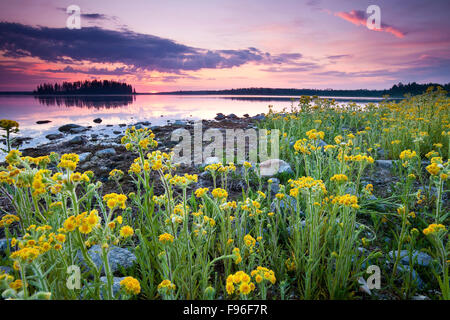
0 113 265 191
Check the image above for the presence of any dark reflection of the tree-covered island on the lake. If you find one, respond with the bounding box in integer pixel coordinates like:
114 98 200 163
34 95 136 109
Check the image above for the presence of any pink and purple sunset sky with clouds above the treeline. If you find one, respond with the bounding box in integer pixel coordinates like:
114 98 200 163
0 0 450 92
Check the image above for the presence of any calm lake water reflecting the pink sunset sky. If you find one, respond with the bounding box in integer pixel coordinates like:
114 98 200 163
0 95 380 158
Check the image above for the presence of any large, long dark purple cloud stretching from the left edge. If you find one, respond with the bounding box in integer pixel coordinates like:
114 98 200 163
0 22 301 73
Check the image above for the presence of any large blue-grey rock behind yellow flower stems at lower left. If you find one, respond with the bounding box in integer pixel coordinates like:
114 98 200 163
77 245 136 274
